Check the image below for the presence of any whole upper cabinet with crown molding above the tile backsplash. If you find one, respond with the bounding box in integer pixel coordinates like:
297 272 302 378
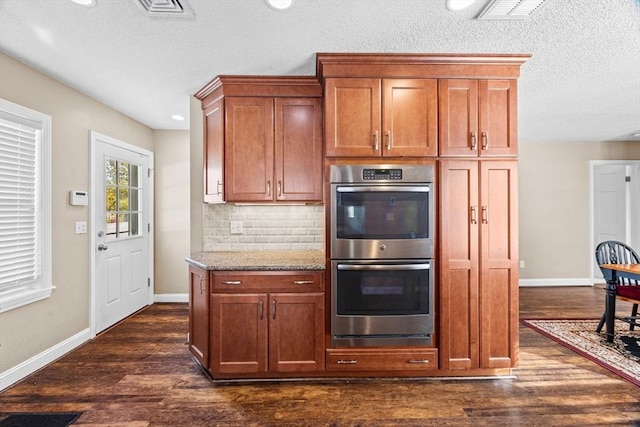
196 76 323 203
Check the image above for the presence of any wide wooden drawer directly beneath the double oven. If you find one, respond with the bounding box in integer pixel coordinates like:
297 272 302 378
327 349 438 371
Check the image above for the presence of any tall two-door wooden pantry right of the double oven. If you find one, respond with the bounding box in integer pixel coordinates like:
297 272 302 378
439 160 518 370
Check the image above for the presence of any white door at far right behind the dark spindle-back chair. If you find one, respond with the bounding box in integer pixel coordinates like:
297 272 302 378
593 165 631 278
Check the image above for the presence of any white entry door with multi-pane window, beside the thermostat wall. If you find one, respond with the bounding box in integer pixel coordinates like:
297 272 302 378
91 132 153 333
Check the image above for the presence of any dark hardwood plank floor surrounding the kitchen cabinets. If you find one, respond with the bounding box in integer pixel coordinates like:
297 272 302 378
0 287 640 427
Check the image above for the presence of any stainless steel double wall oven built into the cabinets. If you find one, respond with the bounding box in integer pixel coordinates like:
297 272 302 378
330 164 435 347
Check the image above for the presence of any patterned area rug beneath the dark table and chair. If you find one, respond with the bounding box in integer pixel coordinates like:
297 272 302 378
522 319 640 386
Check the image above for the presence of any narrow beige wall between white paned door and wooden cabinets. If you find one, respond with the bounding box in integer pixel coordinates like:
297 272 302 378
153 130 190 296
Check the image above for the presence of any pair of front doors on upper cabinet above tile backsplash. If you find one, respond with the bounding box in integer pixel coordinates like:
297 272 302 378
225 97 322 202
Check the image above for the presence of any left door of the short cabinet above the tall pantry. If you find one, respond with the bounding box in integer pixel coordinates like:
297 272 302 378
438 79 478 157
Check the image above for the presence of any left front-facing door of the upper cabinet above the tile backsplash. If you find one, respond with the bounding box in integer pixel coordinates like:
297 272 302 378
225 98 275 202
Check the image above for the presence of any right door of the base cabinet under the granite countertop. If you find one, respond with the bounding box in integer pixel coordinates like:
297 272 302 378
269 293 324 372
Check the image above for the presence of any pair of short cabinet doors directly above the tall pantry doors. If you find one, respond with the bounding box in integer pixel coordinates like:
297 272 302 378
438 79 518 157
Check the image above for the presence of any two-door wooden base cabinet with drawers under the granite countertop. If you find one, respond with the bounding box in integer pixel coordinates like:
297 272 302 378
210 272 325 376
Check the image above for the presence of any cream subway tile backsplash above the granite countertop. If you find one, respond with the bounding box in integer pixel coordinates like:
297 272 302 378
202 204 324 251
